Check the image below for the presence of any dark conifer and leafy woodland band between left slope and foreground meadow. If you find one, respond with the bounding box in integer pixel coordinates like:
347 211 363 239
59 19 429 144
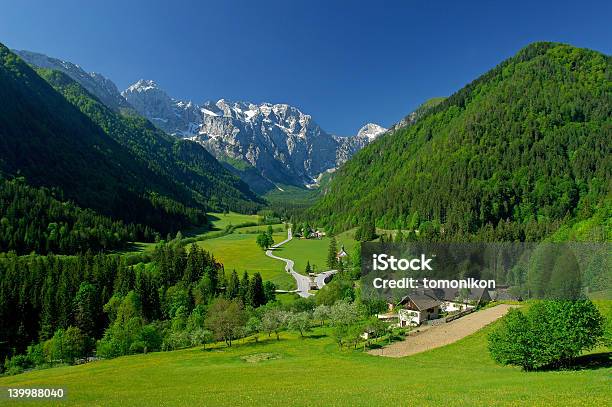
0 239 275 366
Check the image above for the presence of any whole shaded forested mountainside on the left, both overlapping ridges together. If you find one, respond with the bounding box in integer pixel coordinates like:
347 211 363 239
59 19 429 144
0 45 259 234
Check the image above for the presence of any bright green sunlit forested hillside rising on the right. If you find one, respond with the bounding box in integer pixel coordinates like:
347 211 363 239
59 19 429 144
310 43 612 240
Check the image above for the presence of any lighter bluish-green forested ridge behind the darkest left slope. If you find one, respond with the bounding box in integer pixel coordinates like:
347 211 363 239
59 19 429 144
39 70 262 212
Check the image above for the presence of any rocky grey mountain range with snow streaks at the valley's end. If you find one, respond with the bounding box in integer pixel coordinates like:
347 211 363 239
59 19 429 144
122 80 386 193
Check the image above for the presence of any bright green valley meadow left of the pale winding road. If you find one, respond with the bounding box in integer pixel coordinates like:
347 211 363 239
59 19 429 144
197 230 295 290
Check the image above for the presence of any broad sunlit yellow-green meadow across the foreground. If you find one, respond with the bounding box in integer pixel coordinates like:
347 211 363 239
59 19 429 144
0 328 612 407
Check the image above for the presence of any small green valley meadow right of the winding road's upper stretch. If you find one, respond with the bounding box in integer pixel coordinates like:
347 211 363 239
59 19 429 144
275 230 359 273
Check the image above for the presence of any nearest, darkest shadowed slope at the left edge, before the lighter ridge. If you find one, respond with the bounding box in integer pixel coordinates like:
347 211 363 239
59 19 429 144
0 44 258 233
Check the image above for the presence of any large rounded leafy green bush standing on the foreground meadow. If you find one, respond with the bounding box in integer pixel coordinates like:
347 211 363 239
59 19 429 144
489 300 604 370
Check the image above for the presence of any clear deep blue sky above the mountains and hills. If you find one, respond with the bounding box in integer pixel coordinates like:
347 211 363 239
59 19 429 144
0 0 612 135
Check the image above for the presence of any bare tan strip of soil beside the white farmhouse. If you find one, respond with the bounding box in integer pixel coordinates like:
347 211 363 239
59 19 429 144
368 304 515 358
